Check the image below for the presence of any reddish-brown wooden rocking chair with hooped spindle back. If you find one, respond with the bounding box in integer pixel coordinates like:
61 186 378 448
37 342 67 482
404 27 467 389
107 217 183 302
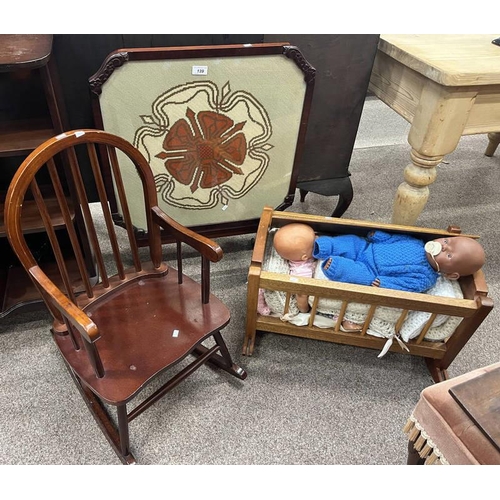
5 130 246 464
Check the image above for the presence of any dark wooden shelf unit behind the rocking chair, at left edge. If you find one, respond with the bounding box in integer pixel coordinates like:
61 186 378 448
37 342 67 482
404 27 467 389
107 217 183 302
0 35 77 318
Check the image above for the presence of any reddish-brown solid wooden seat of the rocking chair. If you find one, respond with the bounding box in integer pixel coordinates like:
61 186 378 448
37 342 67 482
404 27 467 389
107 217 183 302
55 267 230 404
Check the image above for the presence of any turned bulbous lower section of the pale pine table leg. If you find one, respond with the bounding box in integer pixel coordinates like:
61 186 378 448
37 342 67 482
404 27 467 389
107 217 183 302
392 149 443 226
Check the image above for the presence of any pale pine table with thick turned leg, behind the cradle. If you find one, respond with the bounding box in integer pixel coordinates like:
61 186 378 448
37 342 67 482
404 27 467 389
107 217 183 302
369 35 500 225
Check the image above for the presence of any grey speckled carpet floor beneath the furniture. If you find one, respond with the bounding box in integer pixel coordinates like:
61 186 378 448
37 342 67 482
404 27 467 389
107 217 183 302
0 100 500 465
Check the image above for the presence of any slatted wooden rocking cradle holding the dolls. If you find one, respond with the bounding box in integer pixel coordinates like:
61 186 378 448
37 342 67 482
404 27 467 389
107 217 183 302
243 207 493 382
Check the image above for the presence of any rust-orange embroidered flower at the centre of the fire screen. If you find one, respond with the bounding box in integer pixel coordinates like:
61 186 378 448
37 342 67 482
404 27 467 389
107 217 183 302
156 108 247 193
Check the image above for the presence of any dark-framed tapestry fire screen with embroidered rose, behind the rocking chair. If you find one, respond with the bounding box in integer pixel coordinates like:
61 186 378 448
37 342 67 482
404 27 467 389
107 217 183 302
89 43 315 236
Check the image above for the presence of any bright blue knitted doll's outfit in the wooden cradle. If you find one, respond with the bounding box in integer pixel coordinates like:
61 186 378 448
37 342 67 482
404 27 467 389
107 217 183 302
313 231 439 292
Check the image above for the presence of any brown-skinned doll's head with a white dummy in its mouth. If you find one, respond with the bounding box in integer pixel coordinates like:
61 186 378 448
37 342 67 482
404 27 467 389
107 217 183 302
425 236 485 280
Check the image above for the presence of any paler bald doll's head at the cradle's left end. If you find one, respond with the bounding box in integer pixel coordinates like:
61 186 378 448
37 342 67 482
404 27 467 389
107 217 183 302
273 222 316 261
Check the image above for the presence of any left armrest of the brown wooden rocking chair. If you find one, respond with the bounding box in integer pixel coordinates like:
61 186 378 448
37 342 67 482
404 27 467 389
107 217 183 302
29 266 100 342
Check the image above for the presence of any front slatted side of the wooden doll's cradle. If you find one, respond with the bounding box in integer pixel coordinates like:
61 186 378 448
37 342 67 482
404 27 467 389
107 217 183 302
243 271 493 382
